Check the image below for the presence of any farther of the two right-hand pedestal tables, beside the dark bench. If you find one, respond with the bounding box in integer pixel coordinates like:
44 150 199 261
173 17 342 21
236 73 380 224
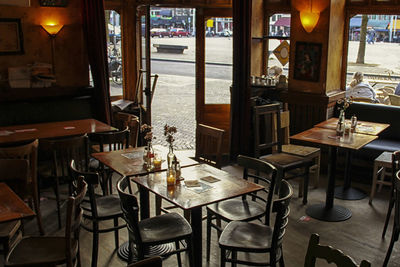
315 118 390 200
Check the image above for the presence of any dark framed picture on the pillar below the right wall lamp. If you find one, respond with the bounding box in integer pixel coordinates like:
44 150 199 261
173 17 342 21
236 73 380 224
293 42 322 82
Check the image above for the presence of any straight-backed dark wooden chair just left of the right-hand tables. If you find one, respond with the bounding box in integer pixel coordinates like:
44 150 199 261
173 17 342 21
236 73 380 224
254 103 313 204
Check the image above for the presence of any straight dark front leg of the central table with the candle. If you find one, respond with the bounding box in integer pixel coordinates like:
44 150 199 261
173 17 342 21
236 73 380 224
191 207 203 267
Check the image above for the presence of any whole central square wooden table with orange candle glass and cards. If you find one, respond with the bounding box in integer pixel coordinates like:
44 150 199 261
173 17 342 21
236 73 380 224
132 164 263 267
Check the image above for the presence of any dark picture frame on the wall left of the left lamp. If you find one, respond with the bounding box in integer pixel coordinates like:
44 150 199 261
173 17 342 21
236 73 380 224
0 18 24 55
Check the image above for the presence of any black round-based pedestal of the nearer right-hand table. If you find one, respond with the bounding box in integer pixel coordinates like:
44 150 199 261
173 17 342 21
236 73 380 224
306 147 351 222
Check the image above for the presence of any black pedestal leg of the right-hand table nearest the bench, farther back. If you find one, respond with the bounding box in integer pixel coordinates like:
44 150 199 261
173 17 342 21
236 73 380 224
335 149 367 200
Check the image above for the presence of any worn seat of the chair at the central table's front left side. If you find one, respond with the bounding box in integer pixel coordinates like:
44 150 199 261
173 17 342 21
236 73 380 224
139 213 192 246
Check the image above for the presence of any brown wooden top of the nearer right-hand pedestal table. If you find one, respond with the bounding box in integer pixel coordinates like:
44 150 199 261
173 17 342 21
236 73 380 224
290 127 378 150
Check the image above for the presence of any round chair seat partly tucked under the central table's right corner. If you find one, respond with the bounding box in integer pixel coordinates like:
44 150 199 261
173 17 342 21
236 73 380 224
207 198 265 221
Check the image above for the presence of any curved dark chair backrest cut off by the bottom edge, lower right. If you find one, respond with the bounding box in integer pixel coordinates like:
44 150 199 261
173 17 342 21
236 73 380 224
304 234 371 267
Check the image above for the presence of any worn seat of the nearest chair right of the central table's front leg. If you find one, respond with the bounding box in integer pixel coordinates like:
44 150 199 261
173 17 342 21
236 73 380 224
219 221 273 252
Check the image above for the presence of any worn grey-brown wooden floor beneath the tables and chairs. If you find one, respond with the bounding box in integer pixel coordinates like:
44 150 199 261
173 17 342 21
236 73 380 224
0 167 400 267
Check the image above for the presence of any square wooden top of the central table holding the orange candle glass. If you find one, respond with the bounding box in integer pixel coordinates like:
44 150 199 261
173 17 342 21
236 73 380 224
132 164 264 210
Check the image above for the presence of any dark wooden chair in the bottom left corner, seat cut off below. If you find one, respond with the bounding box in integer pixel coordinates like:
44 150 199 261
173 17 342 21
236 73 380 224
5 176 87 267
